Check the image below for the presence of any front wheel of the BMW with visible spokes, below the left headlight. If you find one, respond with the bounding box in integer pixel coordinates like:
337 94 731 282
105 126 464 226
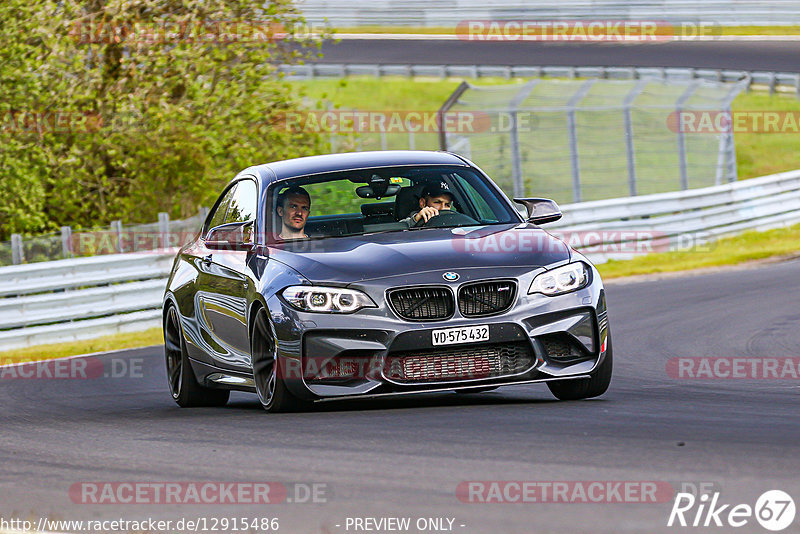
250 308 311 413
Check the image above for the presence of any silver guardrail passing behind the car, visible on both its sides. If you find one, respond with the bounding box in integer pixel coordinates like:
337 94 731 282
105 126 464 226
0 170 800 350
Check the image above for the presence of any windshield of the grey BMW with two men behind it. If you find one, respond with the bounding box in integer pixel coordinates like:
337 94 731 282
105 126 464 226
268 166 520 241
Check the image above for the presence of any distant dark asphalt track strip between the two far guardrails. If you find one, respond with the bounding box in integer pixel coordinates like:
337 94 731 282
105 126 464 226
316 39 800 72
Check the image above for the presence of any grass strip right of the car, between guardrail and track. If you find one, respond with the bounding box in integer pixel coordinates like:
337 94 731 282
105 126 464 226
597 225 800 279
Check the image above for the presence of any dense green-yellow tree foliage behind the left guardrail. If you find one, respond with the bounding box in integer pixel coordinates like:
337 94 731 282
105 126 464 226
0 0 325 239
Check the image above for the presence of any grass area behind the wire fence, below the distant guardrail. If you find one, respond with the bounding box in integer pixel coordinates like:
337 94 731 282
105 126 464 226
292 76 800 202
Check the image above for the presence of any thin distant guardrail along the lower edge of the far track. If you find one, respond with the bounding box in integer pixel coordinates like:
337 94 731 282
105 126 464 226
279 63 800 98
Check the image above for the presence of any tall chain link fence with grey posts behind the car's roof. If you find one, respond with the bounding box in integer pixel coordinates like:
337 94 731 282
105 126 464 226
440 79 746 203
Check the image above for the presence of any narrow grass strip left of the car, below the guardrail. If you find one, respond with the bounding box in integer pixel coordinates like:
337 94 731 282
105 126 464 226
0 328 164 364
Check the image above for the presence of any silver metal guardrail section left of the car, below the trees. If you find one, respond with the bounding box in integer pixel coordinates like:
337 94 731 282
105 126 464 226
0 254 175 350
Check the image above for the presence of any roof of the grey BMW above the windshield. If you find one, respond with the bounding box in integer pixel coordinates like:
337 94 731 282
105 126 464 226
242 150 469 184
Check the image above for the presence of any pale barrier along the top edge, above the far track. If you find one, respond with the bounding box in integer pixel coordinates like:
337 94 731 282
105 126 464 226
298 0 800 27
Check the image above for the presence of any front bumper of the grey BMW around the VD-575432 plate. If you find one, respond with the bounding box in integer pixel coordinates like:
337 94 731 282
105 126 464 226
268 267 608 399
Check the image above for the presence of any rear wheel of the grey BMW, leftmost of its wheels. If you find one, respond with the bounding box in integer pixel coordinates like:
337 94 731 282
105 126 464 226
164 305 231 408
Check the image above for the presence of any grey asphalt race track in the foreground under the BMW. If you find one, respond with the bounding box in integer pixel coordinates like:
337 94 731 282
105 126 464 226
0 261 800 534
